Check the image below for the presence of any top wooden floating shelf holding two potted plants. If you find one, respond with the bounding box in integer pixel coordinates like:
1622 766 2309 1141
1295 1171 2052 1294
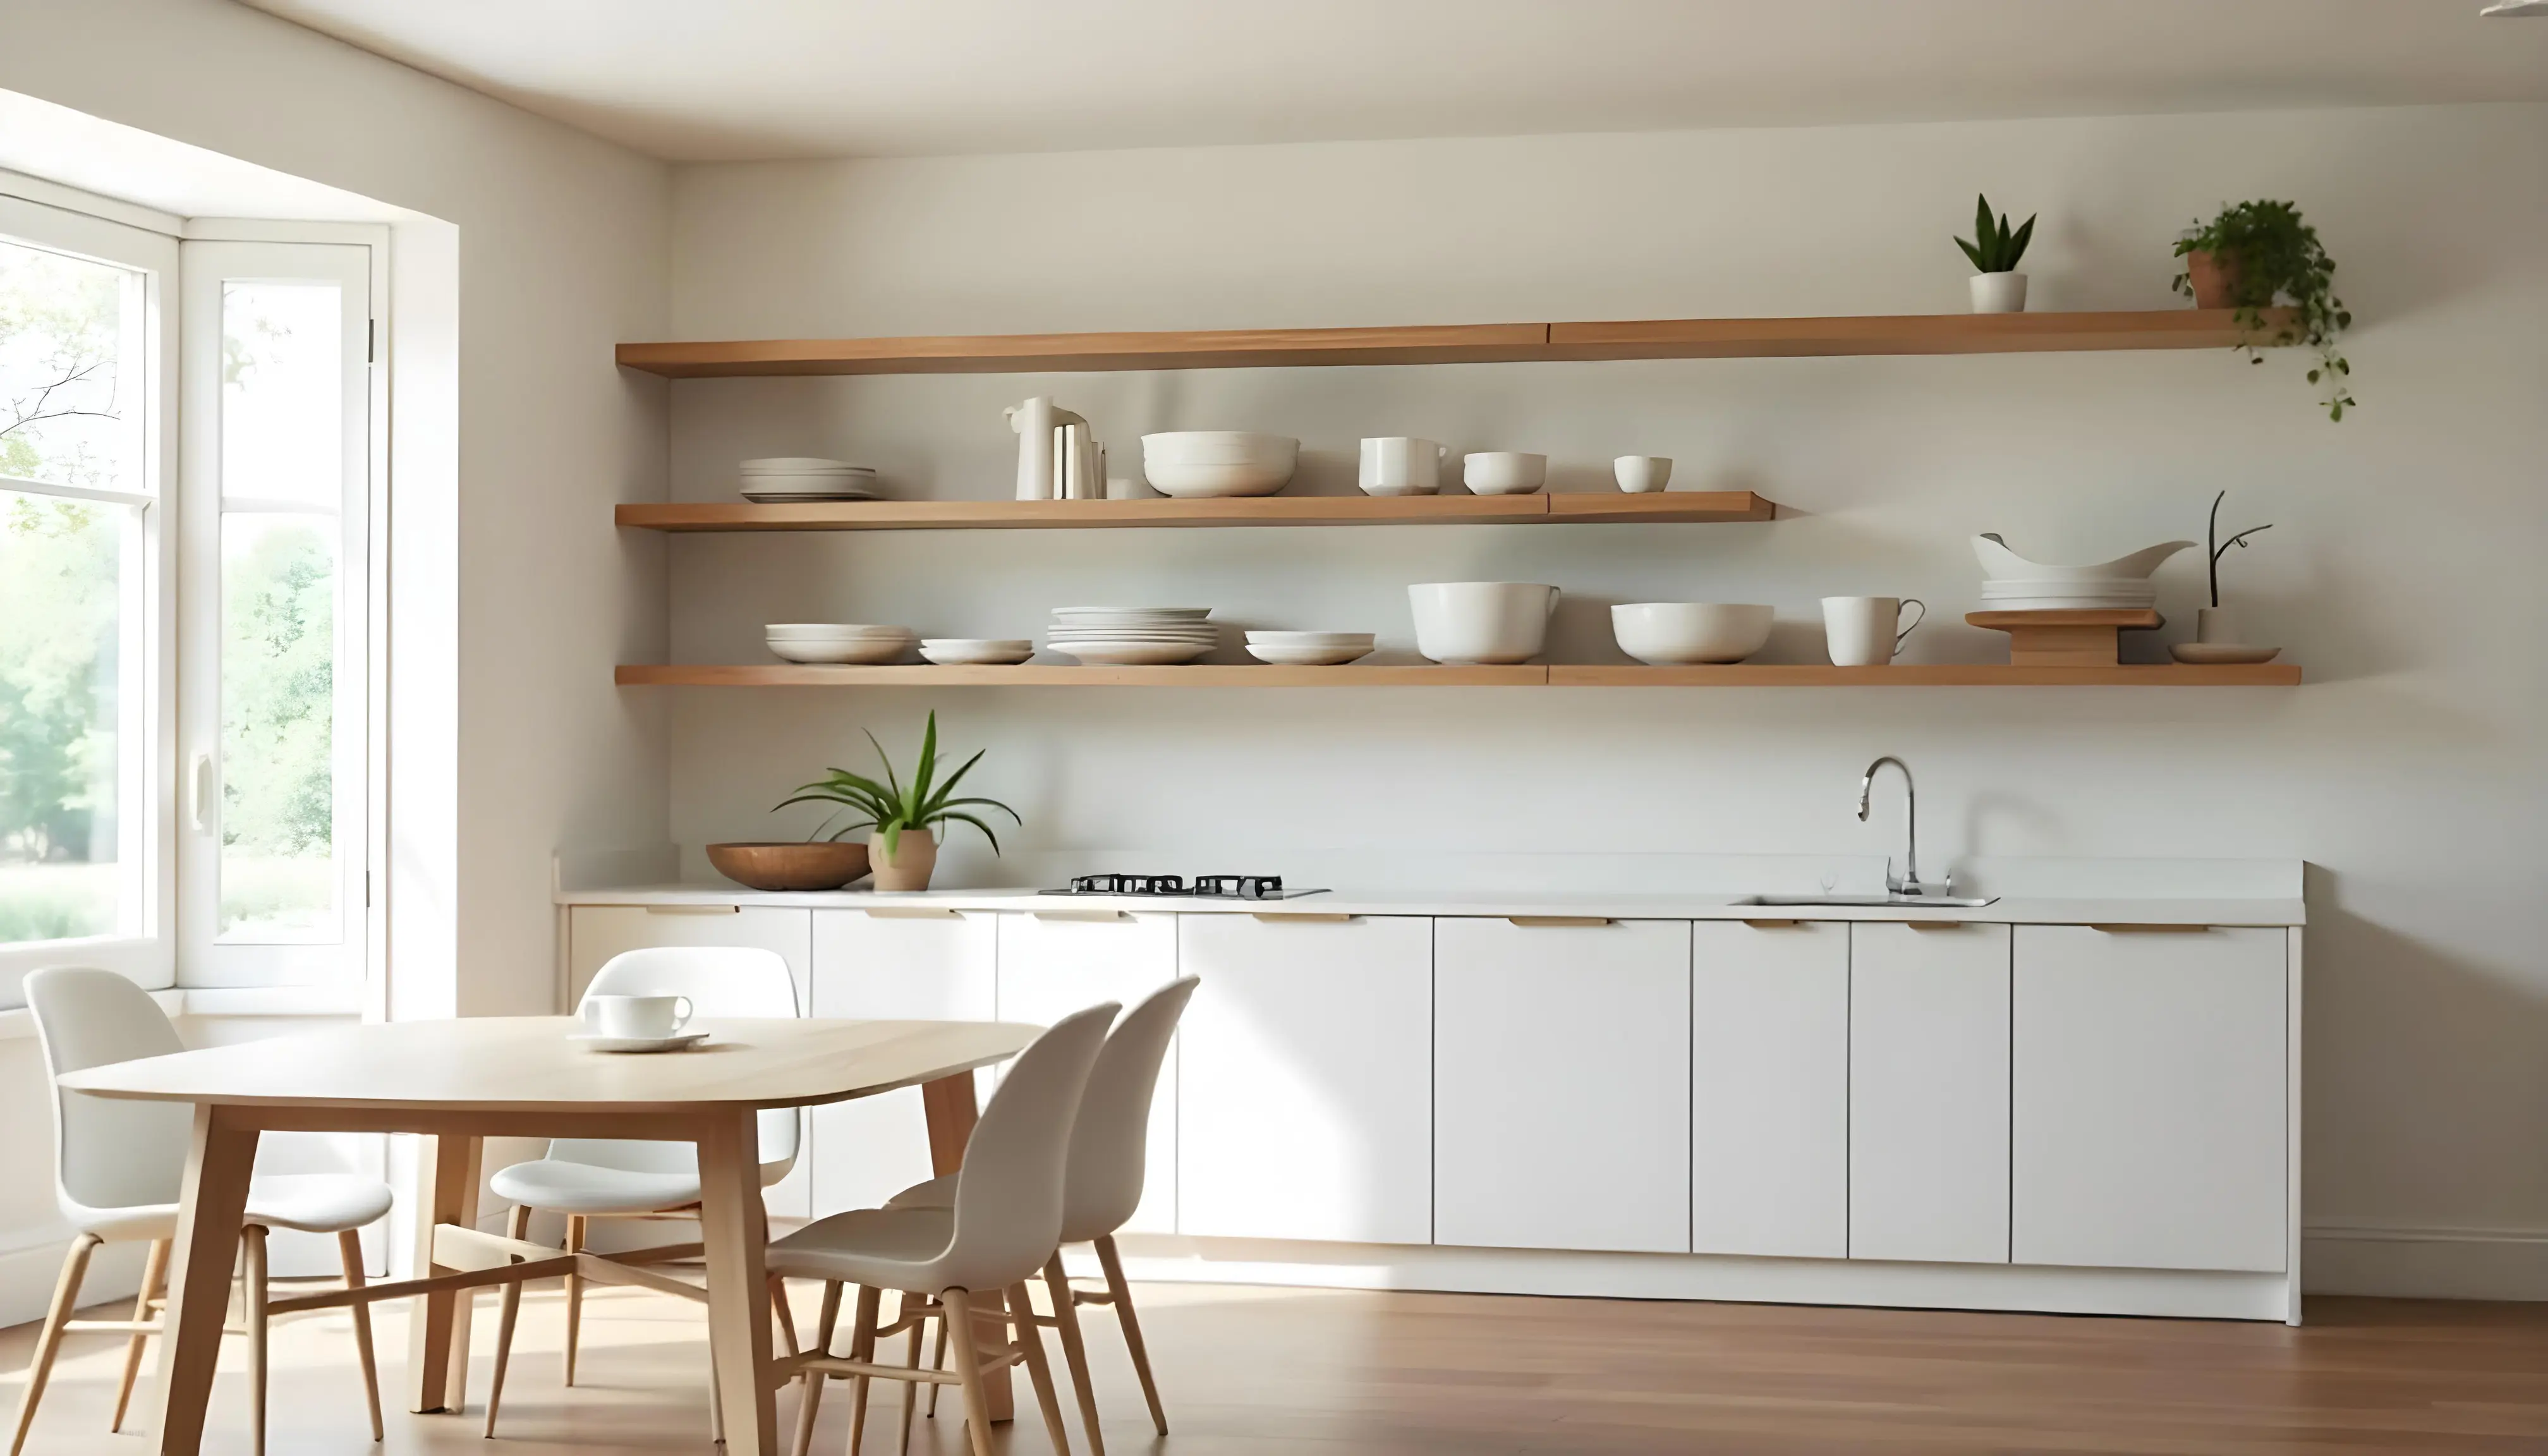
619 308 2283 380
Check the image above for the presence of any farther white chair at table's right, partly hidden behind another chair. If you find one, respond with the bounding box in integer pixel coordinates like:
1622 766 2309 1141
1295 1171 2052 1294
884 976 1203 1456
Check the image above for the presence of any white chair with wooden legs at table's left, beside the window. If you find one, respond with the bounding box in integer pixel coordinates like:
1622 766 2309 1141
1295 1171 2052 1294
10 966 390 1456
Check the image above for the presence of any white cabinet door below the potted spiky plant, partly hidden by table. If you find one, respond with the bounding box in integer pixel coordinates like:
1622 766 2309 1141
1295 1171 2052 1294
813 911 999 1219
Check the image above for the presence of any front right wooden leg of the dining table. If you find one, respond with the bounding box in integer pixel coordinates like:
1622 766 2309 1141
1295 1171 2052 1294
698 1112 777 1456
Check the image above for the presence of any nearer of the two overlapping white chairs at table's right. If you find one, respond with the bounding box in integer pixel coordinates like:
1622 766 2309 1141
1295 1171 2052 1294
770 1002 1116 1456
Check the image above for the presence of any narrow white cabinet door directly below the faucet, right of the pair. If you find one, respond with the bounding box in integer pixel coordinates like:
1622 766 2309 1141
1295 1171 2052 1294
1850 921 2008 1265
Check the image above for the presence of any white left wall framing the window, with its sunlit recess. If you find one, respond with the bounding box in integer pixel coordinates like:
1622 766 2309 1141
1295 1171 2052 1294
0 0 670 1323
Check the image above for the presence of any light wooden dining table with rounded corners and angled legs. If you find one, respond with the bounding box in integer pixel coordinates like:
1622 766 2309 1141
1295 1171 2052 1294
61 1017 1040 1456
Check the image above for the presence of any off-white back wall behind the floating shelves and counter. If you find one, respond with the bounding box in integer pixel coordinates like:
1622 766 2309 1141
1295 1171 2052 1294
665 104 2548 1295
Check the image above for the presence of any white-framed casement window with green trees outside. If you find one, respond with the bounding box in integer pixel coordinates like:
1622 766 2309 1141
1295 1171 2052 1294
0 179 382 1007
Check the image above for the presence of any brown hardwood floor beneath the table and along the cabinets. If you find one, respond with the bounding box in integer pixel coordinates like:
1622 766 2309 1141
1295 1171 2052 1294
0 1285 2548 1456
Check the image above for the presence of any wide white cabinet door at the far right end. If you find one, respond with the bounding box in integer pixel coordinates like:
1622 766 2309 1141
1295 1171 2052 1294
2013 926 2291 1272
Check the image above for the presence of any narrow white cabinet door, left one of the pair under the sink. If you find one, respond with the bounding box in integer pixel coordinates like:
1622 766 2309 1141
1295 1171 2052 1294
1689 921 1850 1259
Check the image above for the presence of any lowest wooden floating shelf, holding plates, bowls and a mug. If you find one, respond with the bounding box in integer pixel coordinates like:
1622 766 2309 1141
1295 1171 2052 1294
619 663 2301 688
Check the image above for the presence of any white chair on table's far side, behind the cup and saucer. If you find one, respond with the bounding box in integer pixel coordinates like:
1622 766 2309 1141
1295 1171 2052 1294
487 946 803 1438
